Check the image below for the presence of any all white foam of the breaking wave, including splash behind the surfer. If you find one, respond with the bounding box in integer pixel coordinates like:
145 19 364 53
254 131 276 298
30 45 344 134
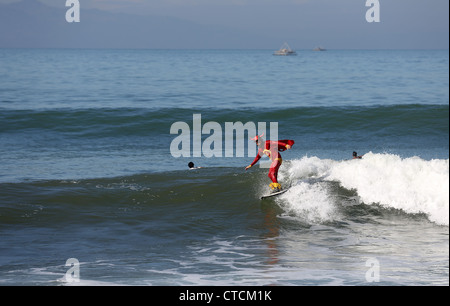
280 152 449 226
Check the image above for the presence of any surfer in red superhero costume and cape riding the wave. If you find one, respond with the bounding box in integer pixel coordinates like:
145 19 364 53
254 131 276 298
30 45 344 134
245 135 295 192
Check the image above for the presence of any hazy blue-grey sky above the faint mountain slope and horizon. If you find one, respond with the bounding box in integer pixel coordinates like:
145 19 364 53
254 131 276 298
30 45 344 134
0 0 449 49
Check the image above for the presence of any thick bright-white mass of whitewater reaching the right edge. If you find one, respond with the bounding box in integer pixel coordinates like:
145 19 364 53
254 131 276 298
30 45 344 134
327 153 449 226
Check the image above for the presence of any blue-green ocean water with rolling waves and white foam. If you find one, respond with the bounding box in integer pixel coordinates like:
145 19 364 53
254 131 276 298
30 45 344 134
0 49 449 286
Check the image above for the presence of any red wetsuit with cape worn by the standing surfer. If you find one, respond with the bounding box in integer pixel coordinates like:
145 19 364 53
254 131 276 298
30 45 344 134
251 140 294 183
